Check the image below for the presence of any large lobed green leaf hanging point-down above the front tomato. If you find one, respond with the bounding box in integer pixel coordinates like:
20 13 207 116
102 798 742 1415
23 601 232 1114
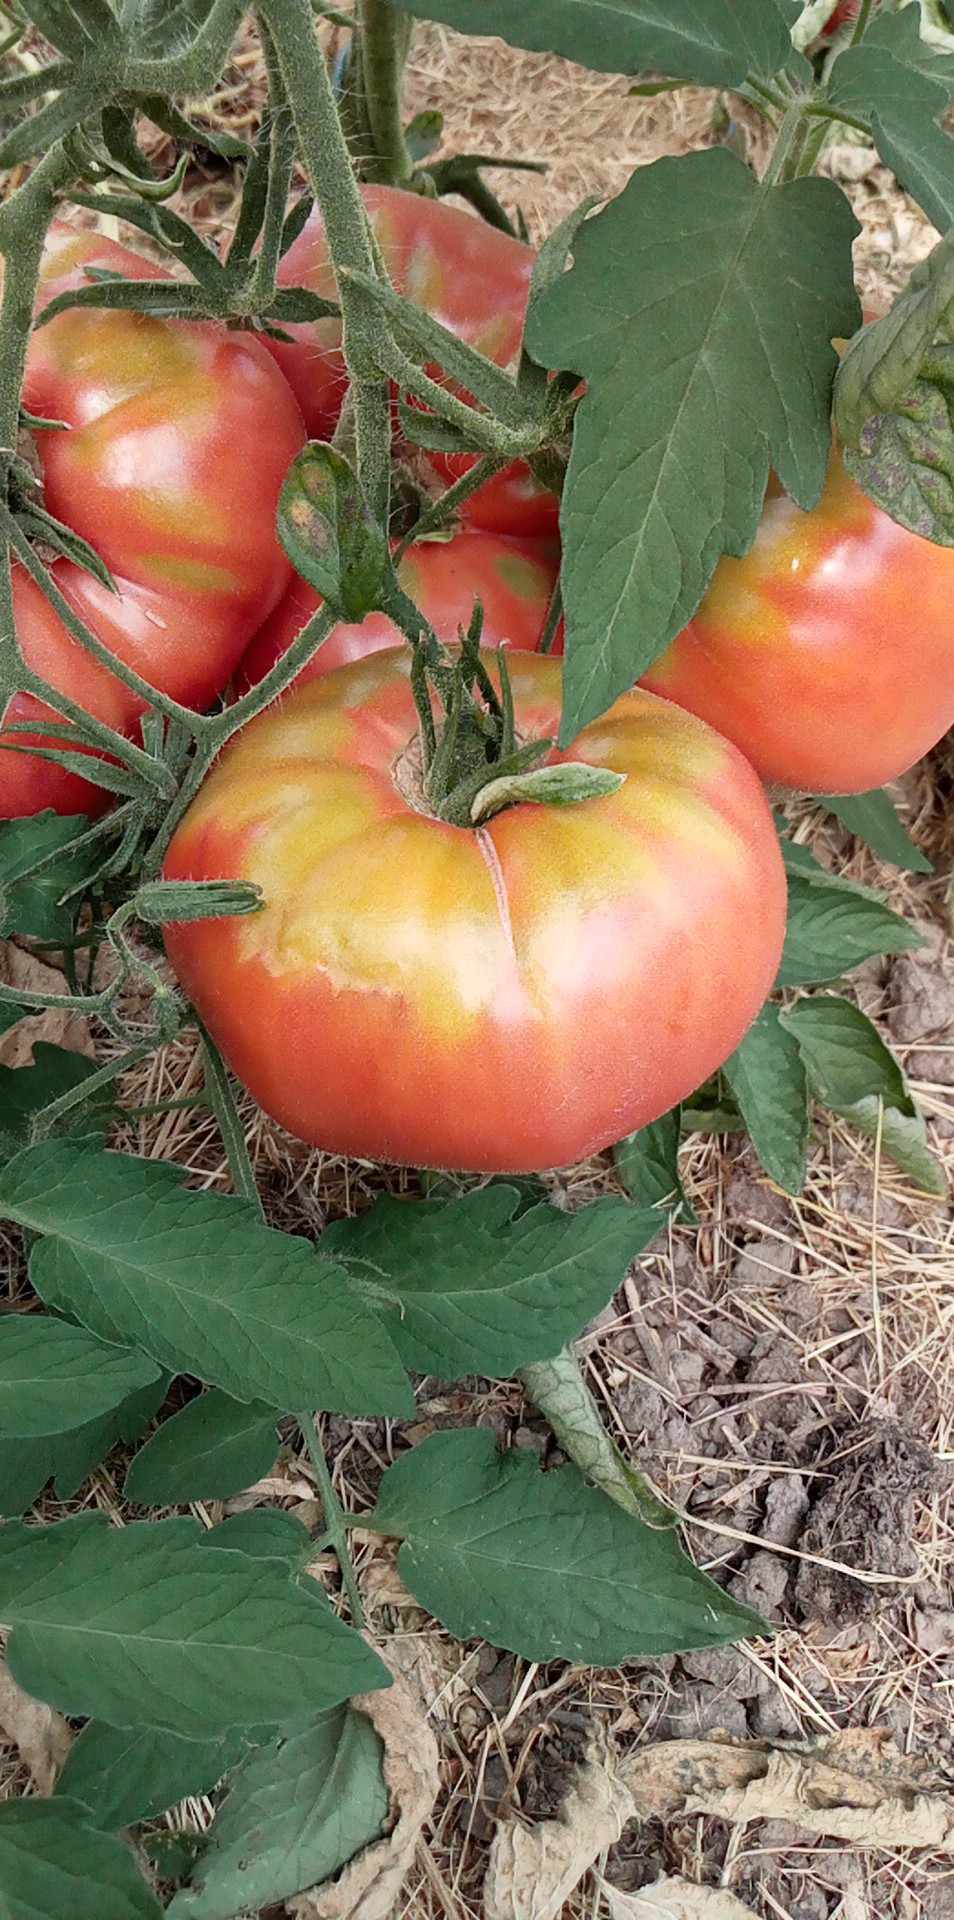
526 148 860 745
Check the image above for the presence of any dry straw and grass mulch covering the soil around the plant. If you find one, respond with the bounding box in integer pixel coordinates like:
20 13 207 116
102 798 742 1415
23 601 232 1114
0 15 954 1920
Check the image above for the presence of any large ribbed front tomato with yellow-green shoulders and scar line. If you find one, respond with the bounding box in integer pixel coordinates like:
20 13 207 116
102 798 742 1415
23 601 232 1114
165 647 785 1171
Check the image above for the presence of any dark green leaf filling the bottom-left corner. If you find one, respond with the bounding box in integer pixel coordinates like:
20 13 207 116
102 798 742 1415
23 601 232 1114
0 1799 161 1920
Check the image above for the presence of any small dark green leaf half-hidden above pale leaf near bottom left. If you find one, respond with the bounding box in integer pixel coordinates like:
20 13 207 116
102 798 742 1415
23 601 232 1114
56 1720 250 1830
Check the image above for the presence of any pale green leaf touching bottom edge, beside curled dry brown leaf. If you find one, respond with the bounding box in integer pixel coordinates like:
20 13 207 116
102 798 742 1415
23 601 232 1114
169 1705 390 1920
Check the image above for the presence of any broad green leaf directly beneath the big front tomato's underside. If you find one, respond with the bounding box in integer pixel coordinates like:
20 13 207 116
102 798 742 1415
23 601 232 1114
322 1185 660 1377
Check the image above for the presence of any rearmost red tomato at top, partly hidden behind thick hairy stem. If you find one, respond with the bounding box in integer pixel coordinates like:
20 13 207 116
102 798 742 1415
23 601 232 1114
267 186 559 534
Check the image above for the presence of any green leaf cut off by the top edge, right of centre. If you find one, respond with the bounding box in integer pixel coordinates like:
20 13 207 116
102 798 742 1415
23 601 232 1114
381 0 793 86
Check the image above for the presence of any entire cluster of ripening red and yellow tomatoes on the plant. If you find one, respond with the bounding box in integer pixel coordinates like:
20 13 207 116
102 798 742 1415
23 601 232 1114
0 202 954 1171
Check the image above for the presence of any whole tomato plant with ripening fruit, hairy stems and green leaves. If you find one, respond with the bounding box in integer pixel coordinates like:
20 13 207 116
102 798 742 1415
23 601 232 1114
0 0 954 1920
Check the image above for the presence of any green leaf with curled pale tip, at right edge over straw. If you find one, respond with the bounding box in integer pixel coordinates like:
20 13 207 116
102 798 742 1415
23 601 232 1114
779 995 946 1194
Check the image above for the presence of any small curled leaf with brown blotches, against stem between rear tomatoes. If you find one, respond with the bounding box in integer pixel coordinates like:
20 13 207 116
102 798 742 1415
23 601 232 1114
278 440 390 620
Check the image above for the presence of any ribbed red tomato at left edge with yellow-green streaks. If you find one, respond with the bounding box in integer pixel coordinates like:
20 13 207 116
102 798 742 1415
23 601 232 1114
0 227 305 818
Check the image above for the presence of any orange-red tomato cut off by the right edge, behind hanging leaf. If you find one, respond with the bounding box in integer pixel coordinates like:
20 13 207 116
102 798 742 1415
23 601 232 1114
643 453 954 793
